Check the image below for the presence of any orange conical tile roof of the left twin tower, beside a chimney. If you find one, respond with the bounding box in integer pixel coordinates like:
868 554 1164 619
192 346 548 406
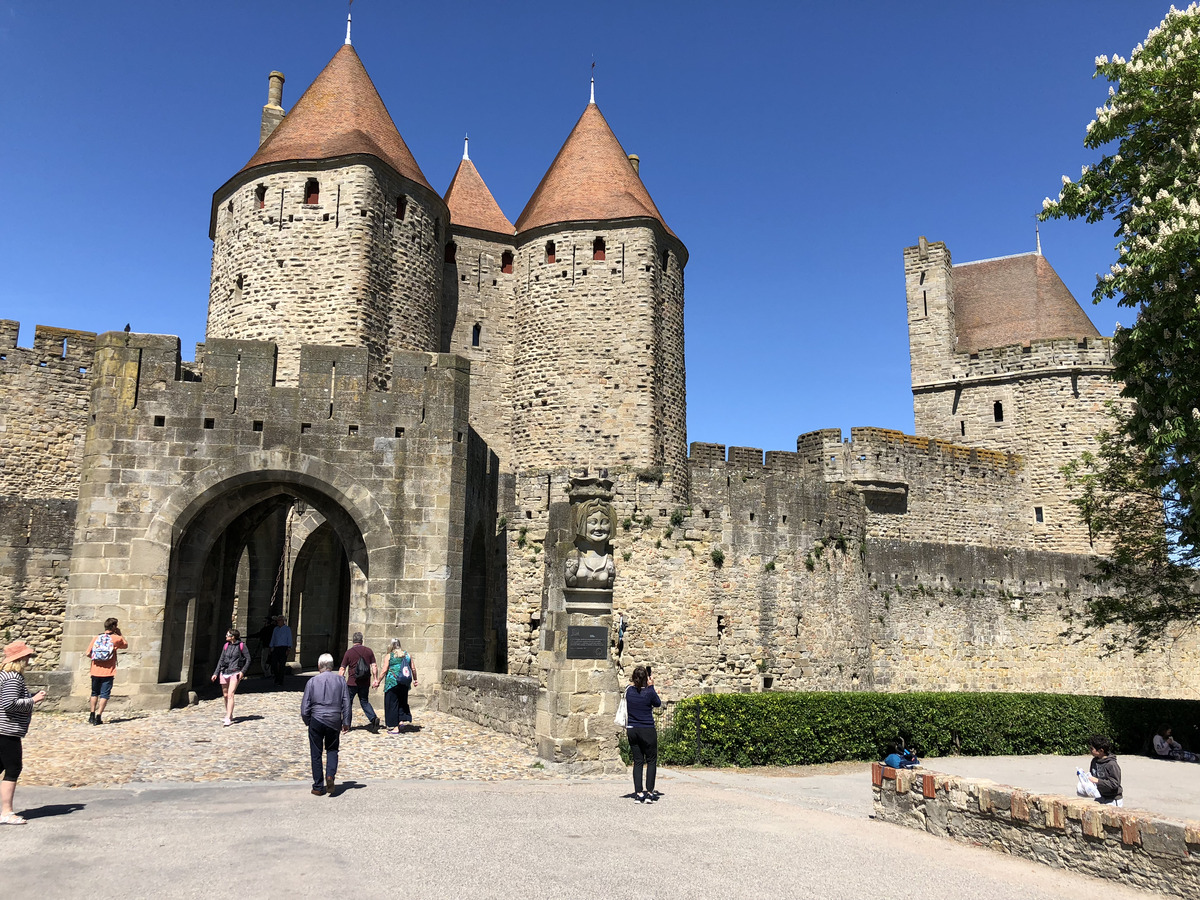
242 44 433 191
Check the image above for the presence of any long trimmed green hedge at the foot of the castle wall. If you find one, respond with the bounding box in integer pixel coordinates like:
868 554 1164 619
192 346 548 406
638 692 1200 766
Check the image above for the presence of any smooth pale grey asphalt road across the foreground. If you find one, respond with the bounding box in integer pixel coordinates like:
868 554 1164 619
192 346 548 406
0 767 1161 900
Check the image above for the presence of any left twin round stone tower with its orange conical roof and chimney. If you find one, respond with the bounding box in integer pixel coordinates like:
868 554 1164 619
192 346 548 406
208 42 450 386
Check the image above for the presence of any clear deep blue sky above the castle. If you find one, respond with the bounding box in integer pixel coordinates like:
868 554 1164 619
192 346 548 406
0 0 1168 458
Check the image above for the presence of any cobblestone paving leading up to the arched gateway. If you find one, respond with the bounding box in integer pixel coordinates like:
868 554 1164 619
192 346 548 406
20 690 557 787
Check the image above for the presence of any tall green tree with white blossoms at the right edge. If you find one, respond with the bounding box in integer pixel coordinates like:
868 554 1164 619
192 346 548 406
1040 4 1200 649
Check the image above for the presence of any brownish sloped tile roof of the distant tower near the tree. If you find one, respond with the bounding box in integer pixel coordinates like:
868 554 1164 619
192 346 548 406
954 253 1100 353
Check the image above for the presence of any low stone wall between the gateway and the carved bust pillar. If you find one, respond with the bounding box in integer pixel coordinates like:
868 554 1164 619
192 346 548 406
431 668 540 746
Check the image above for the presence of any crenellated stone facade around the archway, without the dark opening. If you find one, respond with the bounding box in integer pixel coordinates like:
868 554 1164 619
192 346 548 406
64 334 468 704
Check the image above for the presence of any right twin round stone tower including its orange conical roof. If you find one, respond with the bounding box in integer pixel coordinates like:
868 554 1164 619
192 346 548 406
512 90 688 486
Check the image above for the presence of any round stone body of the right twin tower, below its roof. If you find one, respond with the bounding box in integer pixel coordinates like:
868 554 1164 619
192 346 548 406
512 223 684 485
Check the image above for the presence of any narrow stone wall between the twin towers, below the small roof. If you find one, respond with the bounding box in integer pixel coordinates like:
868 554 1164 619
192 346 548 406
442 228 517 469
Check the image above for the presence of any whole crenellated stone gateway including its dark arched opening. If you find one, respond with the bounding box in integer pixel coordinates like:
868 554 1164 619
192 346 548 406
62 332 477 707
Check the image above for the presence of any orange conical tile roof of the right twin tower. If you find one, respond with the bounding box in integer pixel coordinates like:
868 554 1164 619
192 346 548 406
517 103 674 236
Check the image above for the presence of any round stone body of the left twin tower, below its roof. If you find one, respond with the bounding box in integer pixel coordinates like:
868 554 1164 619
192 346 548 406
208 161 449 386
